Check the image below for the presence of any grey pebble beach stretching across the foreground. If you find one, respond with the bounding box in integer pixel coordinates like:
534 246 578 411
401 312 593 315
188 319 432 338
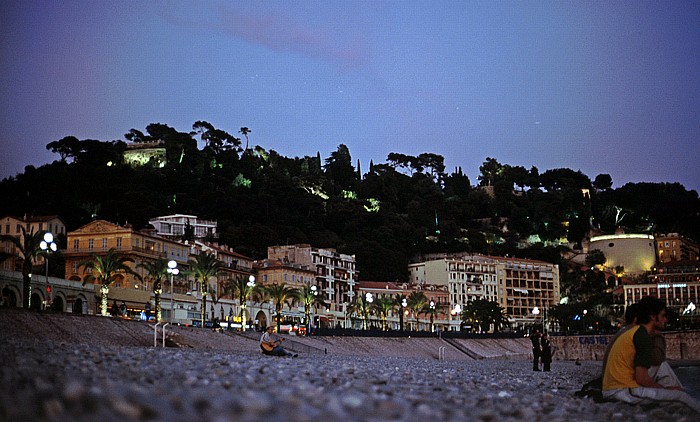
0 310 697 421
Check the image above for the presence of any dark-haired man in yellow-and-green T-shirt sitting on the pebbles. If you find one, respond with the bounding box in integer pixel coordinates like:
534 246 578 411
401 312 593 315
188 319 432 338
603 297 700 412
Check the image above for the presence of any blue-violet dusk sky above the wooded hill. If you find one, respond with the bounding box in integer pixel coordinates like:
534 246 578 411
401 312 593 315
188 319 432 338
0 0 700 191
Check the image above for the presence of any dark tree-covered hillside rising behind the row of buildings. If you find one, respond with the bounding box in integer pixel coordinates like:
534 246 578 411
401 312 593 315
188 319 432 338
0 121 700 281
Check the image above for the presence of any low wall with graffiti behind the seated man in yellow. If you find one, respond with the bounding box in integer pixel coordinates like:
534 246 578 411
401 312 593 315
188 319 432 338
551 331 700 360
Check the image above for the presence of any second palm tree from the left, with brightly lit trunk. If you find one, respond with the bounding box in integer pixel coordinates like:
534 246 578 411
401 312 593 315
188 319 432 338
79 248 141 316
